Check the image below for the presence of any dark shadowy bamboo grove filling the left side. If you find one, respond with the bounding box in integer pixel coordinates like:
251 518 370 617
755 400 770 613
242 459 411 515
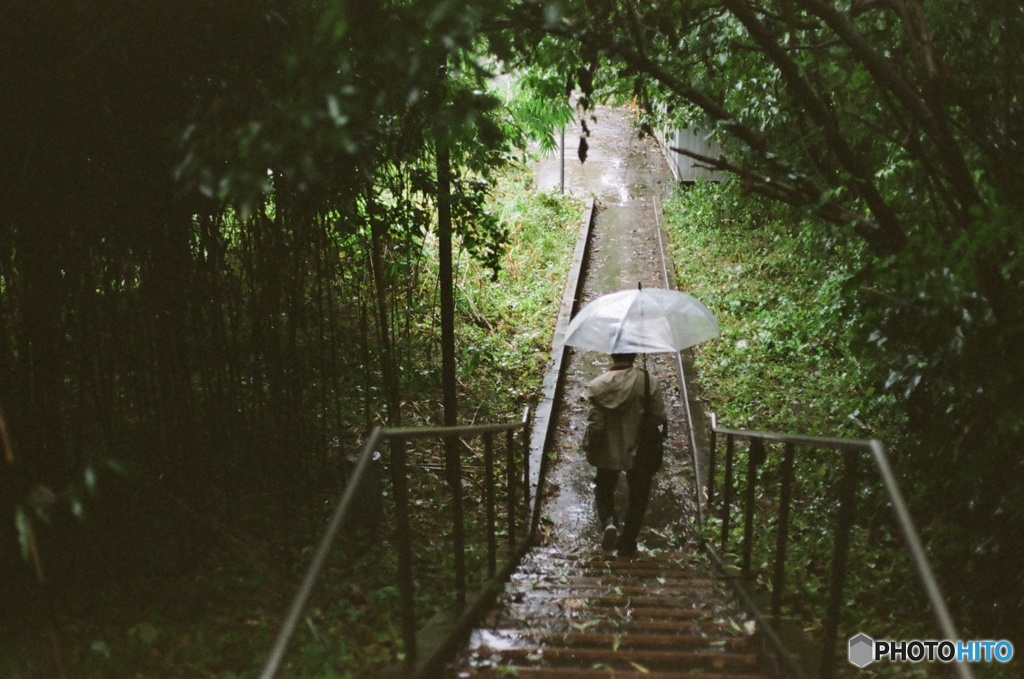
0 2 536 602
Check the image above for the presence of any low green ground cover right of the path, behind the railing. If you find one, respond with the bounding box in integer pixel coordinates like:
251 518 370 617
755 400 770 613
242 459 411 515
666 182 1019 676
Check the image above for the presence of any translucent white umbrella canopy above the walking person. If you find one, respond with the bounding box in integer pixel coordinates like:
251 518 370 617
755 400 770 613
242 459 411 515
565 288 719 353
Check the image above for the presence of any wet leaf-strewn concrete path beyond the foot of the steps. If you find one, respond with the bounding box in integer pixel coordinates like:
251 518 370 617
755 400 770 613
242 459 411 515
538 108 695 553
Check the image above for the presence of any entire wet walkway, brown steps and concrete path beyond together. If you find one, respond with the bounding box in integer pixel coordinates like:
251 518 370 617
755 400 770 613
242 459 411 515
449 108 761 678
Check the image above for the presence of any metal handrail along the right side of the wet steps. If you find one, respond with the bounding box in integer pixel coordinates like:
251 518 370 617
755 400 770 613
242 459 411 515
700 413 974 679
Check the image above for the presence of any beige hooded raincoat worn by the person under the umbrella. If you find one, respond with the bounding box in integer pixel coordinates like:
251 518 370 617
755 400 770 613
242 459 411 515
584 368 667 471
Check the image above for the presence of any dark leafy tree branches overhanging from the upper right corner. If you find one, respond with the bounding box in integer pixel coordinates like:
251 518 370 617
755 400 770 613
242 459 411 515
507 0 1024 456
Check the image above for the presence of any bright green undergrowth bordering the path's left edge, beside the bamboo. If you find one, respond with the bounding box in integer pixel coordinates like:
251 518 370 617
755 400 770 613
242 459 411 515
395 161 581 421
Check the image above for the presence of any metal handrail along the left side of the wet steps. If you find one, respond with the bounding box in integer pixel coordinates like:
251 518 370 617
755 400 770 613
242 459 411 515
260 407 543 679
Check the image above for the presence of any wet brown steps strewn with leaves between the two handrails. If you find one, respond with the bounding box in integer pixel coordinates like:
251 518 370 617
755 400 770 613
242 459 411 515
450 548 768 679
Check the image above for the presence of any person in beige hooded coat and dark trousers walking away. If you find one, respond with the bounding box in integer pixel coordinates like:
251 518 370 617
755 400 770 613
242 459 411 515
584 353 668 556
